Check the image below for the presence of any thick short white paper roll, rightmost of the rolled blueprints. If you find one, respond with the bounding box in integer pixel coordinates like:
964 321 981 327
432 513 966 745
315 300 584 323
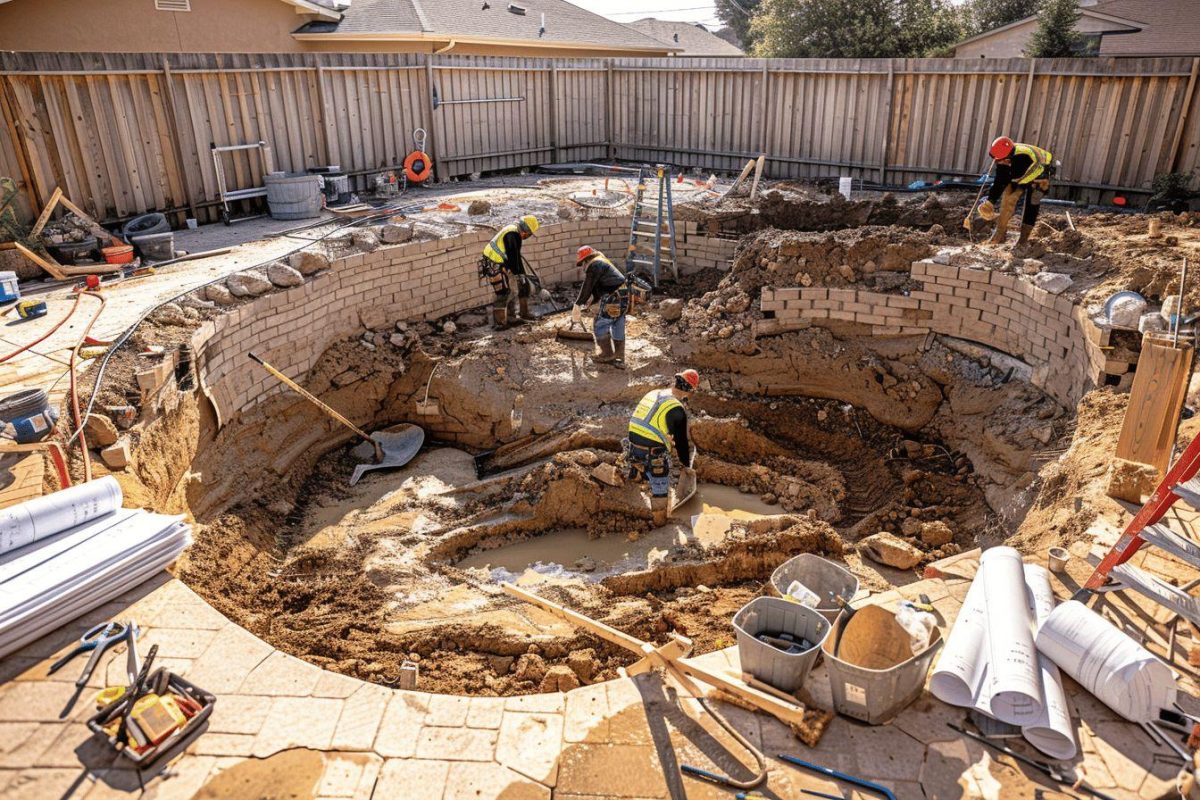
1037 600 1176 722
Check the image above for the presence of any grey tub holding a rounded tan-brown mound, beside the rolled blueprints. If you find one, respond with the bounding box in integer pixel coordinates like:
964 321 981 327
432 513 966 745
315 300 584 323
822 606 942 724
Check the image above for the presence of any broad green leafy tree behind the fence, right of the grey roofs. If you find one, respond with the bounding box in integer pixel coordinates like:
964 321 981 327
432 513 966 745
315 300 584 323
750 0 964 59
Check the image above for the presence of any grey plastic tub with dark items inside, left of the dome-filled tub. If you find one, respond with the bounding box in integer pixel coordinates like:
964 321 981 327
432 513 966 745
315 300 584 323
733 597 829 692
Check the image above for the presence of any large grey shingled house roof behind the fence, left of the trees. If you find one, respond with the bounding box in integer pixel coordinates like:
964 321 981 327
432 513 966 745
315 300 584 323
295 0 678 53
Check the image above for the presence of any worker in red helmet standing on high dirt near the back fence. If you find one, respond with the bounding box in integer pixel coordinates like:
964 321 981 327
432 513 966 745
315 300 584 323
979 136 1056 247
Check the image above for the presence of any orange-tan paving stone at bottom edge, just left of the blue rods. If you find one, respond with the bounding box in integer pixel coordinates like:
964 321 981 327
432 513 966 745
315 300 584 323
554 744 668 798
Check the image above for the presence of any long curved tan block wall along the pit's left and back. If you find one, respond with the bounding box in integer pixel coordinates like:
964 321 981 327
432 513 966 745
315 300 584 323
192 217 736 425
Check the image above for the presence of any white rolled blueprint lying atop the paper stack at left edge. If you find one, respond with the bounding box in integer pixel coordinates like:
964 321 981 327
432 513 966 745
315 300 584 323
0 475 121 553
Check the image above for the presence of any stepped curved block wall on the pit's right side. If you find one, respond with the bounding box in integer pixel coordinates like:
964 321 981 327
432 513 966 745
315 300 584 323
757 260 1113 405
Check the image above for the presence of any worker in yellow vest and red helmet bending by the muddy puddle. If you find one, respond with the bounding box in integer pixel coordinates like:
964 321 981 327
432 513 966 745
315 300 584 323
625 369 700 528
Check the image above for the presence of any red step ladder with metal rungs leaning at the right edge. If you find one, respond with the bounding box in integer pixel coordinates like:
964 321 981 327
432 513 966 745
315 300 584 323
1075 437 1200 626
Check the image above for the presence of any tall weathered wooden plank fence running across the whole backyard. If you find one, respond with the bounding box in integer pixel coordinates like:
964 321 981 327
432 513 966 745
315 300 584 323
0 53 1200 225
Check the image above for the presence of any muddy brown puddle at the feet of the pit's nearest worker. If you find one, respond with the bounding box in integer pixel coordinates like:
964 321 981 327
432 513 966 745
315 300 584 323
457 483 780 583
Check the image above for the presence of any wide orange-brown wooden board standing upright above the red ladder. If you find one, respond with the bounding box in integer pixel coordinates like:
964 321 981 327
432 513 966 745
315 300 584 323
1116 336 1193 474
